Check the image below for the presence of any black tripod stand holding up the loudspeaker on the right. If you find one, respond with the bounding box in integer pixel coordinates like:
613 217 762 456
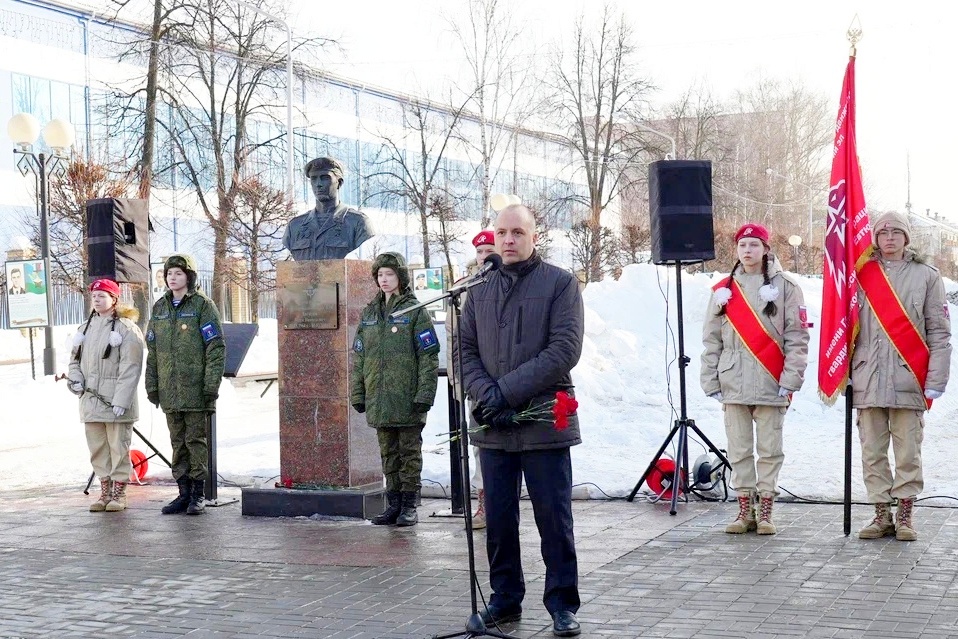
628 261 731 515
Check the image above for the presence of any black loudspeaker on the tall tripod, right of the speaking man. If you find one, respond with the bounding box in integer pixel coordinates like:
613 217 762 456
649 160 715 264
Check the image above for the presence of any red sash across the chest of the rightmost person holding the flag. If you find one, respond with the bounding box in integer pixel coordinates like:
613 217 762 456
858 260 931 408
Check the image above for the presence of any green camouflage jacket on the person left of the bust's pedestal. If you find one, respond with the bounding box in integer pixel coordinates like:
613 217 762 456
146 290 226 413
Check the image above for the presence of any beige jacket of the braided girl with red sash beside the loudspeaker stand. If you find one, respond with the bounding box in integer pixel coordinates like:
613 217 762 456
701 259 808 406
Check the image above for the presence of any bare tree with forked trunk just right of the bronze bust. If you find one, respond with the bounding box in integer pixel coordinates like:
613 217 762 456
366 94 465 268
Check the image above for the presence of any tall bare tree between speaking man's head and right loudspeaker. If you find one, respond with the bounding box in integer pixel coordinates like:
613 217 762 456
552 5 652 280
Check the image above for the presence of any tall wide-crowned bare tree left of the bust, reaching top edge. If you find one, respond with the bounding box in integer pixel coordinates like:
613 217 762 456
114 0 325 304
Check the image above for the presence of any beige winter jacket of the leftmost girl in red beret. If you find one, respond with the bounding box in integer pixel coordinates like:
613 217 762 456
67 315 143 423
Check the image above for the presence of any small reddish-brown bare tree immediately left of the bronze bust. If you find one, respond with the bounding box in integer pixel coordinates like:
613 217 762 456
229 177 293 323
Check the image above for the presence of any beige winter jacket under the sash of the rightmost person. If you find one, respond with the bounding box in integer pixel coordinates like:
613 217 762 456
851 248 951 410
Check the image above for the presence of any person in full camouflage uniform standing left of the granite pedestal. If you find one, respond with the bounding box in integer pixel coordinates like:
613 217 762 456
146 254 226 515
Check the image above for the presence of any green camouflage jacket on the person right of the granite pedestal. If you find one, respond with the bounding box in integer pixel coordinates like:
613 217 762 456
349 289 439 428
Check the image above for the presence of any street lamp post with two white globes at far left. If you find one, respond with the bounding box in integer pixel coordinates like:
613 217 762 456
7 113 76 375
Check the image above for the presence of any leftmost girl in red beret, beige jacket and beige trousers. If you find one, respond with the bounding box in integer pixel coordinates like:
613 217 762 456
67 279 143 512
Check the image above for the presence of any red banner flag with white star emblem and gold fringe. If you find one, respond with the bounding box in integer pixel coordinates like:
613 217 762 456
818 56 872 405
